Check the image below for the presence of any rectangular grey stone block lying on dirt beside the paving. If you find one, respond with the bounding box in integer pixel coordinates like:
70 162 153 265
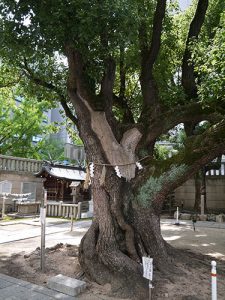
47 274 86 296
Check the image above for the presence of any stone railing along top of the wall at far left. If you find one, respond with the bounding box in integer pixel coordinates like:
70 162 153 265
0 155 43 173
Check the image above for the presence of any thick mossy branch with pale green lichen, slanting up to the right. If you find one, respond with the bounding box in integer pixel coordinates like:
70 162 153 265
134 120 225 213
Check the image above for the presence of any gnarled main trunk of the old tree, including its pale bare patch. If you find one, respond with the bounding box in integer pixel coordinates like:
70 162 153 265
69 92 169 300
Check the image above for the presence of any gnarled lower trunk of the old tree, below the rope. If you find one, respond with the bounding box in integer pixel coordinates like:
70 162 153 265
79 167 169 299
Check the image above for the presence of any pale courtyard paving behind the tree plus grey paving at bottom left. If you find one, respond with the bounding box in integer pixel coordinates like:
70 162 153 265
0 219 225 300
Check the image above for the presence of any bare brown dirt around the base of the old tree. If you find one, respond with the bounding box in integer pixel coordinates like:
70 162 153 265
0 243 225 300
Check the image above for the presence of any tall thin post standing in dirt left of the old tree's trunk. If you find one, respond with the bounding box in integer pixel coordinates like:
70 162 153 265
40 190 47 272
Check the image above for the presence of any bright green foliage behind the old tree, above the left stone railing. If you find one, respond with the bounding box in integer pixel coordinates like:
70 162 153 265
0 63 59 158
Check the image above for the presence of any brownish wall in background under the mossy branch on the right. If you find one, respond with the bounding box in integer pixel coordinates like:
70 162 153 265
175 176 225 211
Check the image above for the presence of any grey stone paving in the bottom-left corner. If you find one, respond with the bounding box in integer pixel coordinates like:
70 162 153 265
0 274 77 300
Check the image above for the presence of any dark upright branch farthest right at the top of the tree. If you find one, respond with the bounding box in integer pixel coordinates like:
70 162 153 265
182 0 208 99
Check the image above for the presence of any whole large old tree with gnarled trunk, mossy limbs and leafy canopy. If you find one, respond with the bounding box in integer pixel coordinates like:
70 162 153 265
0 0 225 299
